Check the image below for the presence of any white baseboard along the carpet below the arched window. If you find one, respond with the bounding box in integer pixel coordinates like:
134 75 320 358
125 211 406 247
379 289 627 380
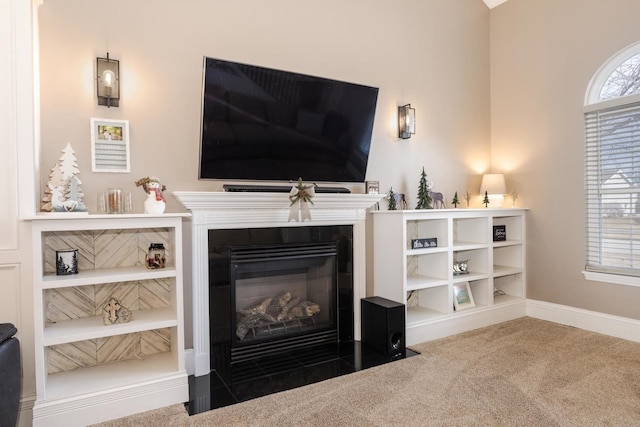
527 300 640 342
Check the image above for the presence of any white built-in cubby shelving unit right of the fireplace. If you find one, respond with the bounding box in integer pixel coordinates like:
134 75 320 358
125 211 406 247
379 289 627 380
373 208 526 345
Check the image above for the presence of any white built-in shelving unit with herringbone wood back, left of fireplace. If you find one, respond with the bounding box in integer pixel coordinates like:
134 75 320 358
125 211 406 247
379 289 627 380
29 213 189 427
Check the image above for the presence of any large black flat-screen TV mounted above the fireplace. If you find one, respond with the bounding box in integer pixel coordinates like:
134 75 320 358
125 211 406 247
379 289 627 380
199 58 378 183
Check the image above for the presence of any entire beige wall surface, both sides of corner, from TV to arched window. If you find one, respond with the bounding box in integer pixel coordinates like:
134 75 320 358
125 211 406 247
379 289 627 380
39 0 640 326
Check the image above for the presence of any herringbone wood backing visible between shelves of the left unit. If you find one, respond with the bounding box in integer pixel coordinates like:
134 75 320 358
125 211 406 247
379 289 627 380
43 229 171 373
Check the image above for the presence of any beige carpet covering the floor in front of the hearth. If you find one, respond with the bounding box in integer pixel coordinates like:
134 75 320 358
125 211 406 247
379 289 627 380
90 318 640 427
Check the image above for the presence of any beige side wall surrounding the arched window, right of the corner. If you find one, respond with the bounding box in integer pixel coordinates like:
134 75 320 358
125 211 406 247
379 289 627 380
491 0 640 319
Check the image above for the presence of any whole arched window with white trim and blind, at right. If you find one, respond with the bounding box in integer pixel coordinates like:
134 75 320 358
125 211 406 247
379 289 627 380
584 42 640 286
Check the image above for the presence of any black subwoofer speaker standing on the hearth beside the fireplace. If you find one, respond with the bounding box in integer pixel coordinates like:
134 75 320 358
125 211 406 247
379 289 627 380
360 297 405 356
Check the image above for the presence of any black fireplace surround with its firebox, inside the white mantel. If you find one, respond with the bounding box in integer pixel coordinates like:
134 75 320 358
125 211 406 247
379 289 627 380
208 225 354 372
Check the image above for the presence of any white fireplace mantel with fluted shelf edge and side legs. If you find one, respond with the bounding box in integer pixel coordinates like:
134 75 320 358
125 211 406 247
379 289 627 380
172 191 384 376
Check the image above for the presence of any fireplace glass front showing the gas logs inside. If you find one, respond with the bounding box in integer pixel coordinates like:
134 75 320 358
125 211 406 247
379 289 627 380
230 243 338 359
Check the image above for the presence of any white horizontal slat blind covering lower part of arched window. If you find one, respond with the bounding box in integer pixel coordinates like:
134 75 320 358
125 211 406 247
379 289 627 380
585 102 640 276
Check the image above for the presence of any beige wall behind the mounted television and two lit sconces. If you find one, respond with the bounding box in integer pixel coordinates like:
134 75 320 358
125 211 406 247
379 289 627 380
39 0 490 211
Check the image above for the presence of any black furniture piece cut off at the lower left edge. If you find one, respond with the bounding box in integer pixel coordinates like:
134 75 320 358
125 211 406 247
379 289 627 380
0 323 22 427
